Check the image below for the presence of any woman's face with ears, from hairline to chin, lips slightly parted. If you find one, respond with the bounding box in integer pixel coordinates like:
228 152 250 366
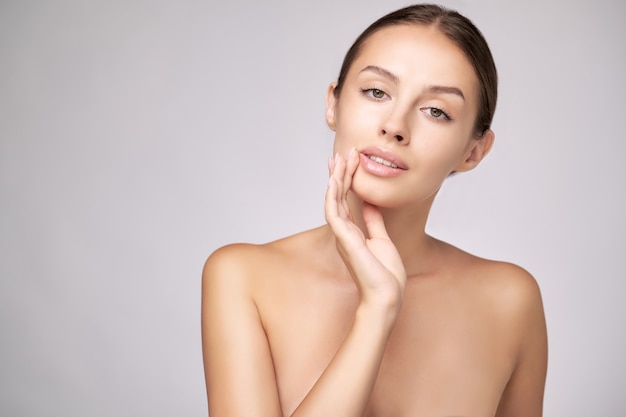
326 25 493 207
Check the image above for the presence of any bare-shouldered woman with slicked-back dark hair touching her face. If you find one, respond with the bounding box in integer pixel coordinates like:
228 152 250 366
202 5 547 417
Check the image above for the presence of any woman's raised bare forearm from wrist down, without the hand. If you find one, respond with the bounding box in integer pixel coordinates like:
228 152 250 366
292 306 397 417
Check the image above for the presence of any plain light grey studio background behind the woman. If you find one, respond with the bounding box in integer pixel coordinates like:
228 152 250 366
0 0 626 417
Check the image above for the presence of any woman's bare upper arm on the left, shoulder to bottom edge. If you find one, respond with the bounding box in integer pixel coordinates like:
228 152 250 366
202 246 281 417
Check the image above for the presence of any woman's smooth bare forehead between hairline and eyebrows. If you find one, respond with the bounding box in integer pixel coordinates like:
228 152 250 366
349 24 478 101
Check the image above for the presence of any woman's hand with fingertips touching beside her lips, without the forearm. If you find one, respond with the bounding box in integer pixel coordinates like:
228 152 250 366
325 149 406 310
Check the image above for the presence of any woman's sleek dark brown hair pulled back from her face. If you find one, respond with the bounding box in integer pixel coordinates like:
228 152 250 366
335 4 498 138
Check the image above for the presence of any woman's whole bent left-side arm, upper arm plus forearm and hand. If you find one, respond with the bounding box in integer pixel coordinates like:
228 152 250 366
202 153 406 417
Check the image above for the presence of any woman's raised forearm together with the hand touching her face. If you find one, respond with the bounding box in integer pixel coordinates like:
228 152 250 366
293 150 406 417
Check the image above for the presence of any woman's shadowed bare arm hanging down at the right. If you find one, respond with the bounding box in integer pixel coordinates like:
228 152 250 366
496 272 548 417
